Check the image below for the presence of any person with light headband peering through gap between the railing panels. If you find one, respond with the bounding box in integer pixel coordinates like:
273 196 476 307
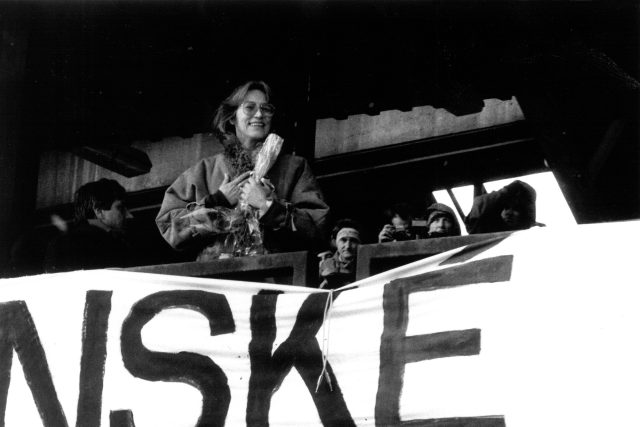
318 218 362 289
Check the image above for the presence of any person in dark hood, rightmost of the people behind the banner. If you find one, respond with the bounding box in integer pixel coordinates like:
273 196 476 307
465 180 543 234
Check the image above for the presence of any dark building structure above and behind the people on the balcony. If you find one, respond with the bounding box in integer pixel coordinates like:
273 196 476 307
0 0 640 276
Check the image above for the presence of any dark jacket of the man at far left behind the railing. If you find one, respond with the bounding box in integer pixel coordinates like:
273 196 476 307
44 221 131 273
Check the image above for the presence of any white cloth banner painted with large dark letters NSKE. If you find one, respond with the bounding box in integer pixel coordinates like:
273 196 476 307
0 222 640 427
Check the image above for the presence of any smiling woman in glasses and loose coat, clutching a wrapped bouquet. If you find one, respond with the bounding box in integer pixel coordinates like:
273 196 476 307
156 81 329 261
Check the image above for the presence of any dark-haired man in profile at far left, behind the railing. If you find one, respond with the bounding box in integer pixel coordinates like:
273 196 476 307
44 178 132 273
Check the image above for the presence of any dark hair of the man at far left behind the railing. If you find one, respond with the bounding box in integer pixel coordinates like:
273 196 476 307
73 178 127 221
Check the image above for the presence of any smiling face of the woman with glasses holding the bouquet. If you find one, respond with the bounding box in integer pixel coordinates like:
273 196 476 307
232 90 272 150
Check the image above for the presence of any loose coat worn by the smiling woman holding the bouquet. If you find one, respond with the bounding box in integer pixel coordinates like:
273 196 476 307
156 153 329 252
